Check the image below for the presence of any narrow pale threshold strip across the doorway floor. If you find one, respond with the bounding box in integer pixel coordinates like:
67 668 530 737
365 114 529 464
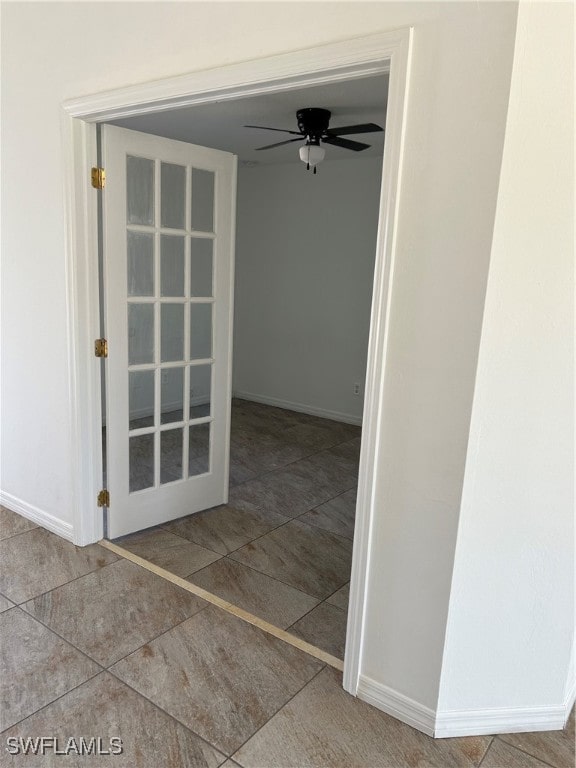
99 540 344 672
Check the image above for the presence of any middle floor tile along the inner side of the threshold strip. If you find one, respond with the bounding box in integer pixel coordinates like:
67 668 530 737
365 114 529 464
188 558 318 629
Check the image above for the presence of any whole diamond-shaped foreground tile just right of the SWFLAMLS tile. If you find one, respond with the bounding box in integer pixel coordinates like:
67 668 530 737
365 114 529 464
112 606 322 755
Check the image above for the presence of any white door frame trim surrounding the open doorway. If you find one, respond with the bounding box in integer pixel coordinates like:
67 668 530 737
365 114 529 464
61 28 413 695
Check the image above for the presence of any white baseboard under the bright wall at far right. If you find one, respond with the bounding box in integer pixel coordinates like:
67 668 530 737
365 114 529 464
434 705 568 739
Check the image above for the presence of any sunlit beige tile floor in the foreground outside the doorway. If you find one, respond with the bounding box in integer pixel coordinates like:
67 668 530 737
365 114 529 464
0 508 574 768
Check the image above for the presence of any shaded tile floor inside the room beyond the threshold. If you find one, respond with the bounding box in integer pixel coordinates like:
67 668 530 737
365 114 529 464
116 400 360 659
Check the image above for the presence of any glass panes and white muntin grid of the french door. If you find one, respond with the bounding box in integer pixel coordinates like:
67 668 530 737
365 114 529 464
126 155 217 493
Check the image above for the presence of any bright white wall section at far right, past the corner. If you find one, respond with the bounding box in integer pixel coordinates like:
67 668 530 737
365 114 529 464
439 3 574 724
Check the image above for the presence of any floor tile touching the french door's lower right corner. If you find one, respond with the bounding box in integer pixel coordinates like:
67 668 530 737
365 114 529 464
163 504 287 555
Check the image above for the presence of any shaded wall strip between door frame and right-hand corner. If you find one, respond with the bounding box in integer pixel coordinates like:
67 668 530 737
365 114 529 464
361 3 517 710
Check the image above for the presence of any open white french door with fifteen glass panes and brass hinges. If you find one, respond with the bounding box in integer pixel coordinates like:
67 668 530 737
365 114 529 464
102 125 236 538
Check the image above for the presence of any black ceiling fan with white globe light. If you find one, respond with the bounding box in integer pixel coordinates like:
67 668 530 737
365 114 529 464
244 107 384 173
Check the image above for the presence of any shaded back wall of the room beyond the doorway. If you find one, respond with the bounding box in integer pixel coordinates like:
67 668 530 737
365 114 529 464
234 154 386 423
